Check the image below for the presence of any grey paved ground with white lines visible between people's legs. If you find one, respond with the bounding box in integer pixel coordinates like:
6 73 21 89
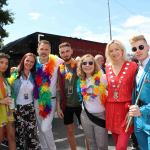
0 118 131 150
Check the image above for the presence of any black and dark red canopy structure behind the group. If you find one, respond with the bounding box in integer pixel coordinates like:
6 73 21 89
1 32 106 66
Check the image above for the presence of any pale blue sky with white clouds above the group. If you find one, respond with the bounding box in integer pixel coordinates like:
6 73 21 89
4 0 150 52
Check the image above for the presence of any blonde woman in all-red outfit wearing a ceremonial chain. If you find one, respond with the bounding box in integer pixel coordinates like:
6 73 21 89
105 40 137 150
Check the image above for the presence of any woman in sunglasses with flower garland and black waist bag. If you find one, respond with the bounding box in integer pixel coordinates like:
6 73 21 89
77 54 108 150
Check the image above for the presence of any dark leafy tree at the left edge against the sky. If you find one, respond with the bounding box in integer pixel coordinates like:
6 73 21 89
0 0 14 47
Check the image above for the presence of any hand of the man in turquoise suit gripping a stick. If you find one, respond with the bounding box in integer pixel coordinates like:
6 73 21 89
129 105 141 117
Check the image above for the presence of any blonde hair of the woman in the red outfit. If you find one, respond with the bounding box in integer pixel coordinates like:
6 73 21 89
105 40 127 63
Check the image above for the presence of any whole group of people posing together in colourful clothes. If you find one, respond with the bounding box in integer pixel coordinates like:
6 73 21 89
0 35 150 150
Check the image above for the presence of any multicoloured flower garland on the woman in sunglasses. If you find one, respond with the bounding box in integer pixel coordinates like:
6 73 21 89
77 71 106 105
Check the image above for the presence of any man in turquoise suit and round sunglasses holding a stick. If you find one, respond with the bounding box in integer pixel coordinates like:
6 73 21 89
129 35 150 150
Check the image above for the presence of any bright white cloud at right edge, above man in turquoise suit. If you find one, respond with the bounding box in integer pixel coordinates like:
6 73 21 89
123 16 150 28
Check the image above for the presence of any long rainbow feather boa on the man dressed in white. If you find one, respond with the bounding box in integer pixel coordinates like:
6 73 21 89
34 54 57 118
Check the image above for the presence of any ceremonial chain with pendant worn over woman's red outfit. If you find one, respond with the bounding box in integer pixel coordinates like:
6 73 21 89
108 62 130 100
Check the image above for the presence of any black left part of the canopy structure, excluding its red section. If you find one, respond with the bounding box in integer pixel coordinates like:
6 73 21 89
1 32 60 65
